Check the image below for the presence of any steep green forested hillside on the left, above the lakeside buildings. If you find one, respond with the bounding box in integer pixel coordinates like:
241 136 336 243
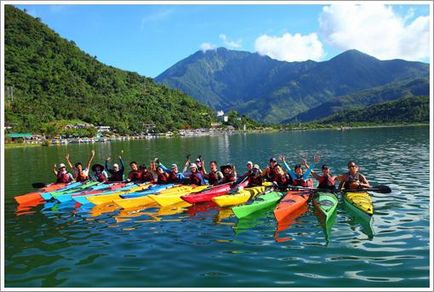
5 5 213 133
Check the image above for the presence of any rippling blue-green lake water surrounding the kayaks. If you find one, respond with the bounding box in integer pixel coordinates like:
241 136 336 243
4 127 430 288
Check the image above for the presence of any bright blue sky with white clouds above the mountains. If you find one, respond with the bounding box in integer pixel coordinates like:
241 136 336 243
17 4 430 77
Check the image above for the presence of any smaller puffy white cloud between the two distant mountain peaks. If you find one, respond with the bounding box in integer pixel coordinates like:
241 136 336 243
255 33 324 62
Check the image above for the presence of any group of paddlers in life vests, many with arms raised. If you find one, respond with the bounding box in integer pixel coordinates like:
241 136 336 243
53 150 370 190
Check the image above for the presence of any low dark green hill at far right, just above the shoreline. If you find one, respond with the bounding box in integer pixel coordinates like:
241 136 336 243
321 96 429 124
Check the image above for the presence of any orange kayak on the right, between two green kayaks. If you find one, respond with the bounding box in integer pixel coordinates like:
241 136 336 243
274 190 310 223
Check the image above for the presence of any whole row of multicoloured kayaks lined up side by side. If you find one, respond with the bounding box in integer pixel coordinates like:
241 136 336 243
15 182 373 228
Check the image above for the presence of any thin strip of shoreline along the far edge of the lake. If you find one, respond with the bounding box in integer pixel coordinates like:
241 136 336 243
4 123 430 149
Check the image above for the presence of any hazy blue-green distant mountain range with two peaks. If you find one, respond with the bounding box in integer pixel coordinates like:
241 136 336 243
155 48 429 123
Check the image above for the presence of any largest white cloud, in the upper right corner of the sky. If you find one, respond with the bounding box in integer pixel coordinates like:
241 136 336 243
319 3 429 60
